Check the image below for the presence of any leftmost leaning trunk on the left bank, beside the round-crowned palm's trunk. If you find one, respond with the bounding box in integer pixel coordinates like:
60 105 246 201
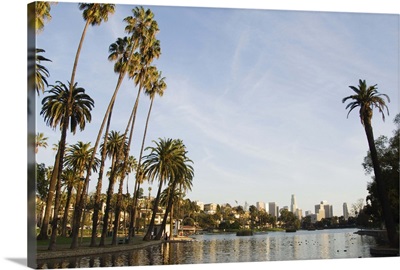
37 149 60 240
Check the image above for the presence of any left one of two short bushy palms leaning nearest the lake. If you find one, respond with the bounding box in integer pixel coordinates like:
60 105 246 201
143 139 189 241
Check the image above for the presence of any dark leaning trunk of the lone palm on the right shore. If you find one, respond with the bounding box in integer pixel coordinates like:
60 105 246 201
364 119 399 248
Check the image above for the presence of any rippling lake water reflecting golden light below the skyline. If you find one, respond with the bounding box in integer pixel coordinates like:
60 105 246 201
37 229 375 269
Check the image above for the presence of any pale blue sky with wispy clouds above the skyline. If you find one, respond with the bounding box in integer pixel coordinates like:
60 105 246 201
32 0 399 215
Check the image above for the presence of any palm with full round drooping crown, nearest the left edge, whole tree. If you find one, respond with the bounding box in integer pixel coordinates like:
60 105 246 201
40 81 94 250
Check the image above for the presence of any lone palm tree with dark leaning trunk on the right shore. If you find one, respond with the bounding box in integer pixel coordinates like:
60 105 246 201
342 80 399 248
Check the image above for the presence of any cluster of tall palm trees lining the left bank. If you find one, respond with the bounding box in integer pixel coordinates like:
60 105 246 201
31 2 193 250
